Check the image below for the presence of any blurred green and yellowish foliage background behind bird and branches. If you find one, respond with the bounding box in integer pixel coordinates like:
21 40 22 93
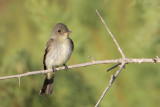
0 0 160 107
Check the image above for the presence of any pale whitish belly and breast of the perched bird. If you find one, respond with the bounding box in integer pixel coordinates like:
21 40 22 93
45 41 72 69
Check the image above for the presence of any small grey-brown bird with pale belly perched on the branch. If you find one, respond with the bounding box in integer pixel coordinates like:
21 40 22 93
39 23 74 95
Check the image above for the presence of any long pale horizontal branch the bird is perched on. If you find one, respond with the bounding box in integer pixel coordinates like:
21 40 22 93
0 57 160 80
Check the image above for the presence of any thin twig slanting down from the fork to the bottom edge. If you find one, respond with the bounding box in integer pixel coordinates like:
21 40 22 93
95 63 125 107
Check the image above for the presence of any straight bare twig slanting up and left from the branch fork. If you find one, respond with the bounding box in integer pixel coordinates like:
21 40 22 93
96 9 126 58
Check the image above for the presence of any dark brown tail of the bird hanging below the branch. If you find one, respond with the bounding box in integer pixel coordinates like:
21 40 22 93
39 74 54 95
